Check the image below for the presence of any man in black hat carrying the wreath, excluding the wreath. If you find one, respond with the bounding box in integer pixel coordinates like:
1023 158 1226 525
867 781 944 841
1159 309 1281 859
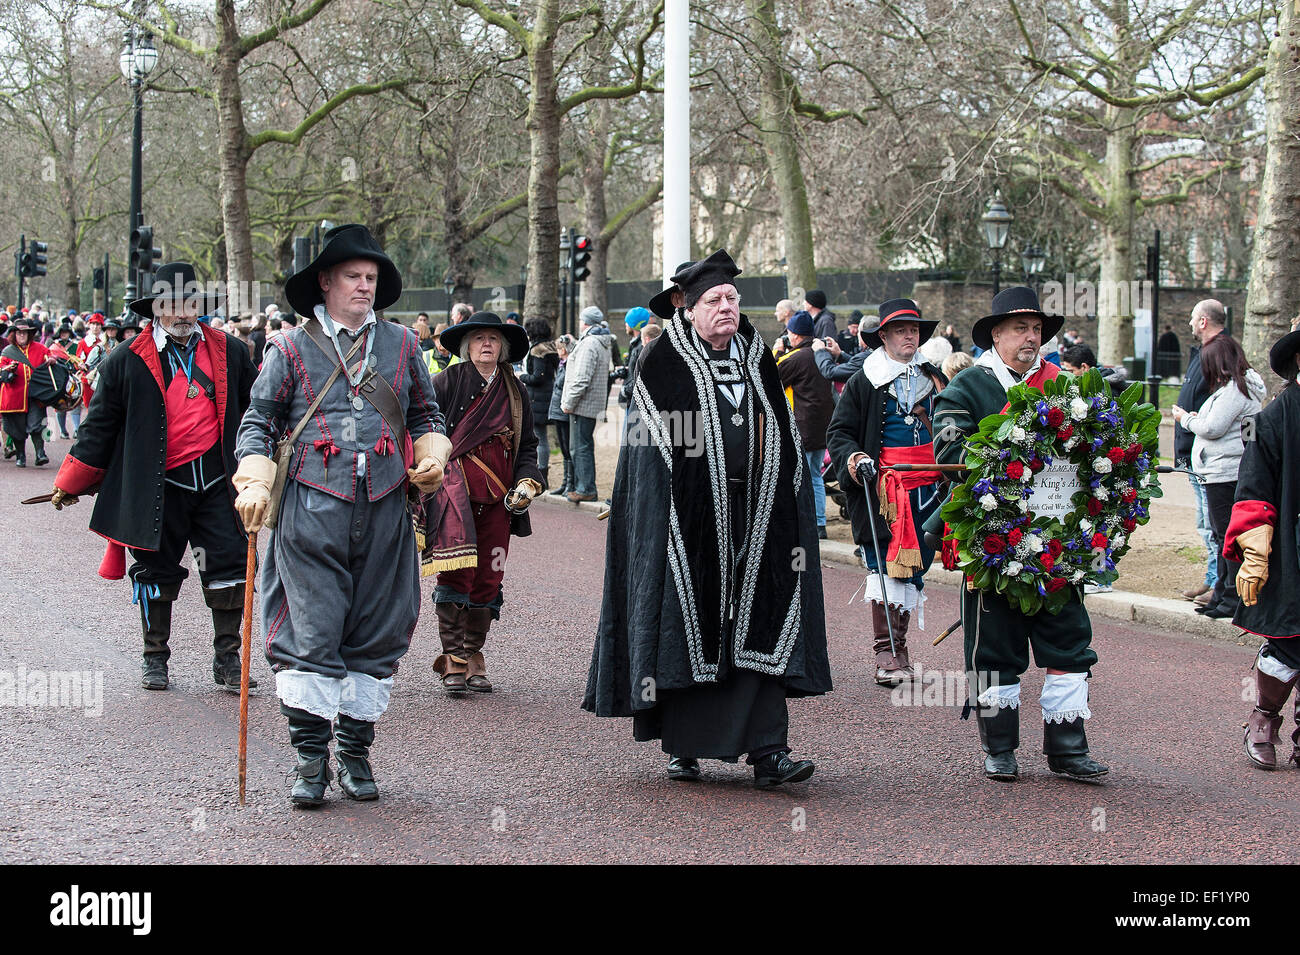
926 286 1109 781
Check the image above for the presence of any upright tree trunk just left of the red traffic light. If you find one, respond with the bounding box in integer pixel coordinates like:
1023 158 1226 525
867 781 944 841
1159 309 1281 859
524 0 560 327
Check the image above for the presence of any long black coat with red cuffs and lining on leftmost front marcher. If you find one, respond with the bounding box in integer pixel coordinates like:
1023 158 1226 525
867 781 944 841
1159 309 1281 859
55 325 257 551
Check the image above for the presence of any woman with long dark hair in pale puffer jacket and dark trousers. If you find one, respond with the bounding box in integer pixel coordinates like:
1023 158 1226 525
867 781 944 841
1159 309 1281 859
1174 335 1268 618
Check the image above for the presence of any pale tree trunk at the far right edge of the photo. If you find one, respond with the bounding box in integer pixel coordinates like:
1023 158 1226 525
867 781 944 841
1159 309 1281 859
1243 0 1300 383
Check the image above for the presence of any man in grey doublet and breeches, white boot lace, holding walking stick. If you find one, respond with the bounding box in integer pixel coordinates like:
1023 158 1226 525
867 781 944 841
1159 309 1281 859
234 225 451 807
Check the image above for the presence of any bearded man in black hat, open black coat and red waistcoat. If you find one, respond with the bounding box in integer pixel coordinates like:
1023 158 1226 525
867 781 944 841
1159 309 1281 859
53 262 257 691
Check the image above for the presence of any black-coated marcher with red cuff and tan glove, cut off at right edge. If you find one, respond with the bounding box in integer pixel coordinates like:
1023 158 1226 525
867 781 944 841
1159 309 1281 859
1223 320 1300 769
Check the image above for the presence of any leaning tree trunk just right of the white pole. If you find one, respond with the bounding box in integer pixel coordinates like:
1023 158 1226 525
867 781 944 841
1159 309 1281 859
748 0 816 291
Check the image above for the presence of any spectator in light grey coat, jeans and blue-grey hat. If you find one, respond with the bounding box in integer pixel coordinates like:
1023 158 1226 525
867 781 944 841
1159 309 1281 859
560 305 614 504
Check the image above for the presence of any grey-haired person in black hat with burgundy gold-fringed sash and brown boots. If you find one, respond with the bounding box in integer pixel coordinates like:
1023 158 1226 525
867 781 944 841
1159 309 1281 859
424 312 542 693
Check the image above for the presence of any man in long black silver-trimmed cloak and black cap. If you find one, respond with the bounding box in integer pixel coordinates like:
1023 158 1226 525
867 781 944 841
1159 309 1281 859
582 251 831 787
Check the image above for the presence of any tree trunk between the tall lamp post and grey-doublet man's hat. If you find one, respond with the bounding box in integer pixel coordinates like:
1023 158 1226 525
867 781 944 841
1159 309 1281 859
216 0 256 316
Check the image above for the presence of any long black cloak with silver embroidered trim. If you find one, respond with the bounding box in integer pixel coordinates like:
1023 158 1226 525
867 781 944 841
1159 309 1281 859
582 316 831 716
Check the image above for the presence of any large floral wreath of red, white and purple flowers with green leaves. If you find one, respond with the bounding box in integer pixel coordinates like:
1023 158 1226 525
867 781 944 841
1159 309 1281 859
943 369 1161 615
